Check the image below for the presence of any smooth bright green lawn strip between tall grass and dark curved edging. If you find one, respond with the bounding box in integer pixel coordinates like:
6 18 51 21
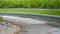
0 9 60 16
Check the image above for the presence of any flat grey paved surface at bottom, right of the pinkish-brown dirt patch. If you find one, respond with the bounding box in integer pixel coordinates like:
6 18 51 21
19 25 60 34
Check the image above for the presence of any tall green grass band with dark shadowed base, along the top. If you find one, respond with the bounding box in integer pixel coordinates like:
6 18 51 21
0 0 60 9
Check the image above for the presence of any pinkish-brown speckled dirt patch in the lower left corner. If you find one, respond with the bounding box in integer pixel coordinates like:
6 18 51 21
0 22 20 34
